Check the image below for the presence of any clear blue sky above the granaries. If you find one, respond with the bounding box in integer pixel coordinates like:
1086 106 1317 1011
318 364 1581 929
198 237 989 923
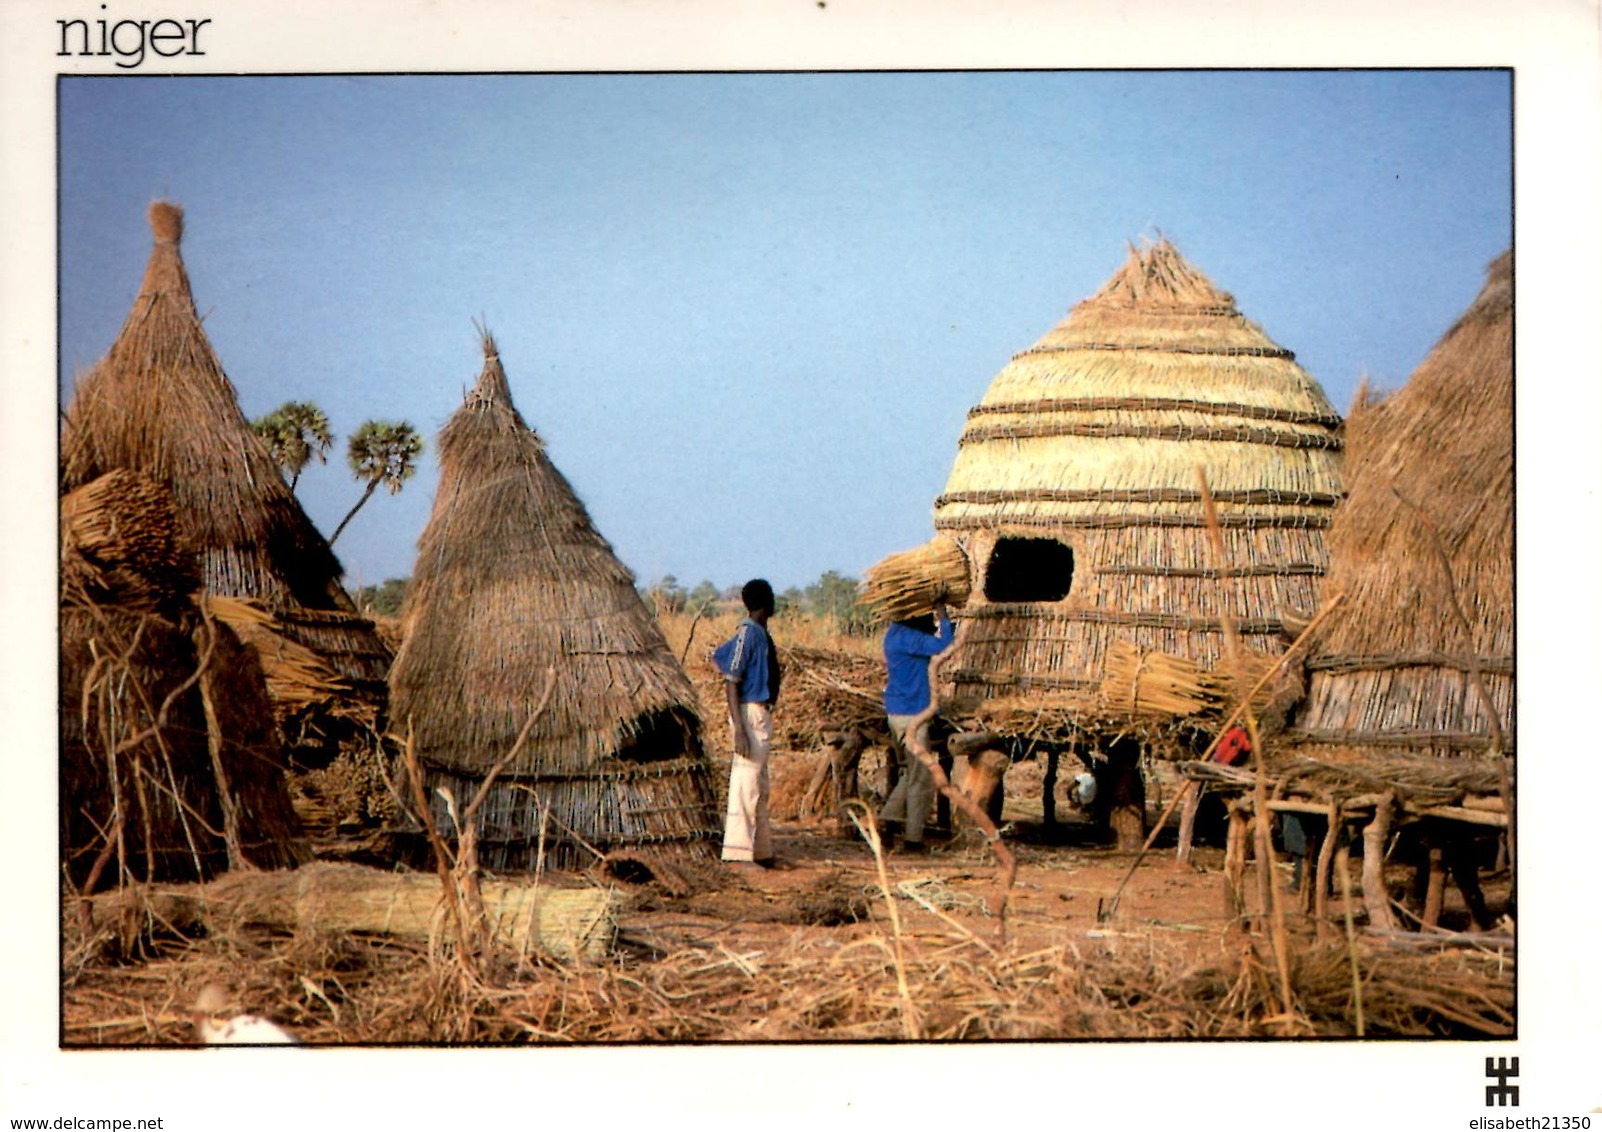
58 70 1512 588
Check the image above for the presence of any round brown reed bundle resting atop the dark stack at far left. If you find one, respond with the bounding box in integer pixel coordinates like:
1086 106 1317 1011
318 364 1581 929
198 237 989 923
61 468 199 607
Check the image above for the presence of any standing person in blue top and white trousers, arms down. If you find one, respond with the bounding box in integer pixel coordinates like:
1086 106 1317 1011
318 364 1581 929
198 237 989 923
711 578 779 868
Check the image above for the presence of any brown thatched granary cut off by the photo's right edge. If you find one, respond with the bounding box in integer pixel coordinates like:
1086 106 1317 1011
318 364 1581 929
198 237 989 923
1288 251 1514 778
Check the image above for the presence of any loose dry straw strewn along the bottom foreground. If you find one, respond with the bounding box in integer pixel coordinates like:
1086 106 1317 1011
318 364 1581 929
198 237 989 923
62 903 1515 1047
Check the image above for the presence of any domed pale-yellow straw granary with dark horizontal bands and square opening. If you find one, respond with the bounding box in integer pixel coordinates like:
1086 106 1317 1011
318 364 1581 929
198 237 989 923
934 240 1341 717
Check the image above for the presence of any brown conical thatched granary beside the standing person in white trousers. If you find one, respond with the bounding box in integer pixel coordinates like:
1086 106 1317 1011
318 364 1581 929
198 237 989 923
389 335 719 869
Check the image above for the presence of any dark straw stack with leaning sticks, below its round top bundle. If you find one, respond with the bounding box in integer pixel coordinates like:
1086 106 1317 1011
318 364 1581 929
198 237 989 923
59 600 309 890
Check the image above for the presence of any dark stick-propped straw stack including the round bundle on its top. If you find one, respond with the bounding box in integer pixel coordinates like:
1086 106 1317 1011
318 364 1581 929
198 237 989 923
59 469 311 889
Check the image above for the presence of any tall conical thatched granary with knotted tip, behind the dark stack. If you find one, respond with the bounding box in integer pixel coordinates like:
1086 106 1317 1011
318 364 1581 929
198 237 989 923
61 202 389 752
